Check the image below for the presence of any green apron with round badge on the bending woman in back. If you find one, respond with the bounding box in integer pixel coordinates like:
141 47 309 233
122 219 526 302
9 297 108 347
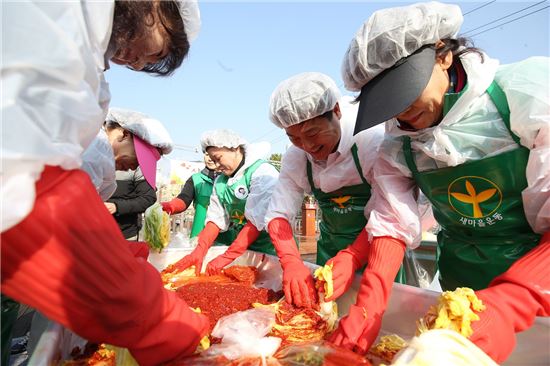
214 159 276 255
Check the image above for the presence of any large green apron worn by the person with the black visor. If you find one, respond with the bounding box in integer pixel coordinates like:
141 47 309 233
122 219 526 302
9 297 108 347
403 81 540 290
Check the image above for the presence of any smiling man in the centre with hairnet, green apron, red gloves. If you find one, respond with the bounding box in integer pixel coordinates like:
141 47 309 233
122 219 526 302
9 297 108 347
266 72 405 312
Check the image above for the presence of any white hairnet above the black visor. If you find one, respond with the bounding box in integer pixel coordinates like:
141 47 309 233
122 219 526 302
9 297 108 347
342 2 463 91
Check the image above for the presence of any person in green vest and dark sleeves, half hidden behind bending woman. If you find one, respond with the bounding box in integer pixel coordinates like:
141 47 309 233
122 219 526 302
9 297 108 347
161 151 235 245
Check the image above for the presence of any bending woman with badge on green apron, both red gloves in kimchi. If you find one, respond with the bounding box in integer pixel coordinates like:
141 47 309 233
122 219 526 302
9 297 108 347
161 129 279 275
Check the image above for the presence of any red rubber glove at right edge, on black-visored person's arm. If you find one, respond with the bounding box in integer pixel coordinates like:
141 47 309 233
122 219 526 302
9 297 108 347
470 232 550 363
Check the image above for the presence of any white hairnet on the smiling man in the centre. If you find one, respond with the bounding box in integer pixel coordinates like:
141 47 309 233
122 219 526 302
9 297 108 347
269 72 340 128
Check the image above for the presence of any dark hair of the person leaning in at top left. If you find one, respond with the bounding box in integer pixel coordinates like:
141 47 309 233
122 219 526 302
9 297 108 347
111 0 189 76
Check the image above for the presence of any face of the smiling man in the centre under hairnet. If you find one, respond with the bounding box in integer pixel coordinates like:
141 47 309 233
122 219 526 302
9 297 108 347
285 104 342 160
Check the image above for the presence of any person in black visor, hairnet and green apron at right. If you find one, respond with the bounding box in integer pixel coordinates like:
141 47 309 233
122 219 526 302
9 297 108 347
333 2 550 363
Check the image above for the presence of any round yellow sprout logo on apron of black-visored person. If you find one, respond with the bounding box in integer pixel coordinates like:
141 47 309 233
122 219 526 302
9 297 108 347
448 176 502 219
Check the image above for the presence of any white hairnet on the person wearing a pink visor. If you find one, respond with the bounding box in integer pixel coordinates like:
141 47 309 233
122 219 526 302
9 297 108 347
105 108 174 154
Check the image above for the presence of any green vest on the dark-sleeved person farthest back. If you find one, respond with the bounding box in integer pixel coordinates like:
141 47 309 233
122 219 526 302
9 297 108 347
190 171 234 245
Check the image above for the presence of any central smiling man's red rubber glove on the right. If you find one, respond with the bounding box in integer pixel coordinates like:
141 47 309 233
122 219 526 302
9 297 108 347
326 229 369 301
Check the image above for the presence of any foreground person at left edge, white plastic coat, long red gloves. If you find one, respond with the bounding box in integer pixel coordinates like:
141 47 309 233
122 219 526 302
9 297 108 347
1 0 212 365
